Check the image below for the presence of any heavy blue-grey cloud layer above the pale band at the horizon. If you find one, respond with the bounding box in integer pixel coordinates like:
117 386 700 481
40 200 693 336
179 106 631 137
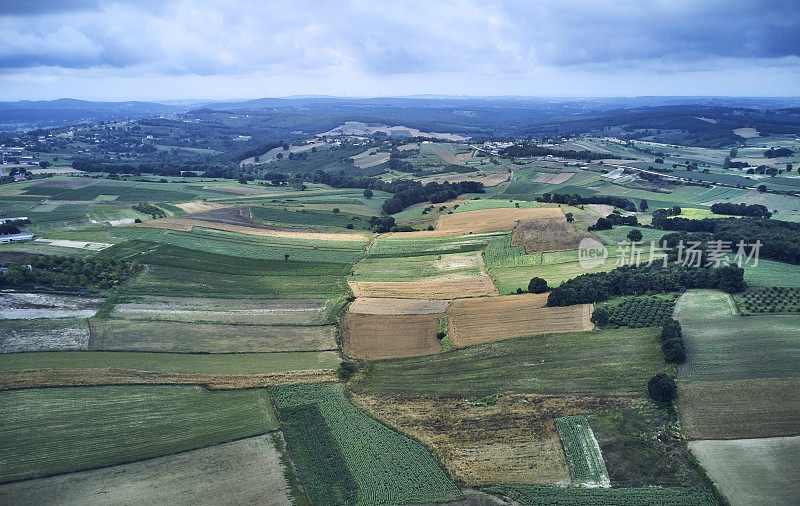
0 0 800 75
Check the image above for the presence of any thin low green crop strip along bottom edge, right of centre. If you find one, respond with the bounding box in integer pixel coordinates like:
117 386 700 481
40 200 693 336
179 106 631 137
483 485 717 506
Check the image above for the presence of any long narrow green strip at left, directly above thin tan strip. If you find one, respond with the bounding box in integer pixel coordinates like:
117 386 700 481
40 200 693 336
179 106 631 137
0 351 339 374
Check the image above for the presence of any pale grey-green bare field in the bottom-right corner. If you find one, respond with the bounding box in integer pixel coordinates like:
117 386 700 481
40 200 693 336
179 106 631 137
689 437 800 506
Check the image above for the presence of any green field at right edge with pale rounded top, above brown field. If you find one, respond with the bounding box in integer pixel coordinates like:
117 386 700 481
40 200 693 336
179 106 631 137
675 290 800 380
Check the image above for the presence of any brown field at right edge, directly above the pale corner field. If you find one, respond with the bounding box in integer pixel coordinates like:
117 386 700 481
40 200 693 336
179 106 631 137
678 378 800 439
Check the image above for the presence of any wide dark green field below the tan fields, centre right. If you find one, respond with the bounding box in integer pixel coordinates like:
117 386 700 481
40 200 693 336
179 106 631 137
354 329 663 397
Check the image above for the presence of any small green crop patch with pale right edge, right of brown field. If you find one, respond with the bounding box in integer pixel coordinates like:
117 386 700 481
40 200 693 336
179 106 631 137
555 415 611 487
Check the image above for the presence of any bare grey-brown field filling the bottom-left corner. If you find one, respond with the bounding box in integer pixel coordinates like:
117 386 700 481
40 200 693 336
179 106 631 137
0 435 292 506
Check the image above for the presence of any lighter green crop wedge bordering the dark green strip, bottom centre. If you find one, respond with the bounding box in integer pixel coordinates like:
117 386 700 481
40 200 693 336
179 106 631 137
273 383 460 505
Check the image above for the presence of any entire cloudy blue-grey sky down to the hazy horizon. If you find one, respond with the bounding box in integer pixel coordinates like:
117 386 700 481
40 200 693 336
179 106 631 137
0 0 800 101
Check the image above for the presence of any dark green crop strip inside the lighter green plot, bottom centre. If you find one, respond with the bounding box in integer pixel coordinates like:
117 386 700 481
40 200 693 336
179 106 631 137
280 404 358 505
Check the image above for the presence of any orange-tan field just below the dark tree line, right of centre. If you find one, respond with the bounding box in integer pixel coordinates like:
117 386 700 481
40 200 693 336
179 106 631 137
448 296 594 346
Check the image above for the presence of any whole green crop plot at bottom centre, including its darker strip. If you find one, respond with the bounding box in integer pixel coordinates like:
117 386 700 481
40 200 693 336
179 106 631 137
272 383 460 504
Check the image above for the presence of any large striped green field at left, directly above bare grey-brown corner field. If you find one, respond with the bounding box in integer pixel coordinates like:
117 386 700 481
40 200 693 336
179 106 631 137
0 387 277 482
